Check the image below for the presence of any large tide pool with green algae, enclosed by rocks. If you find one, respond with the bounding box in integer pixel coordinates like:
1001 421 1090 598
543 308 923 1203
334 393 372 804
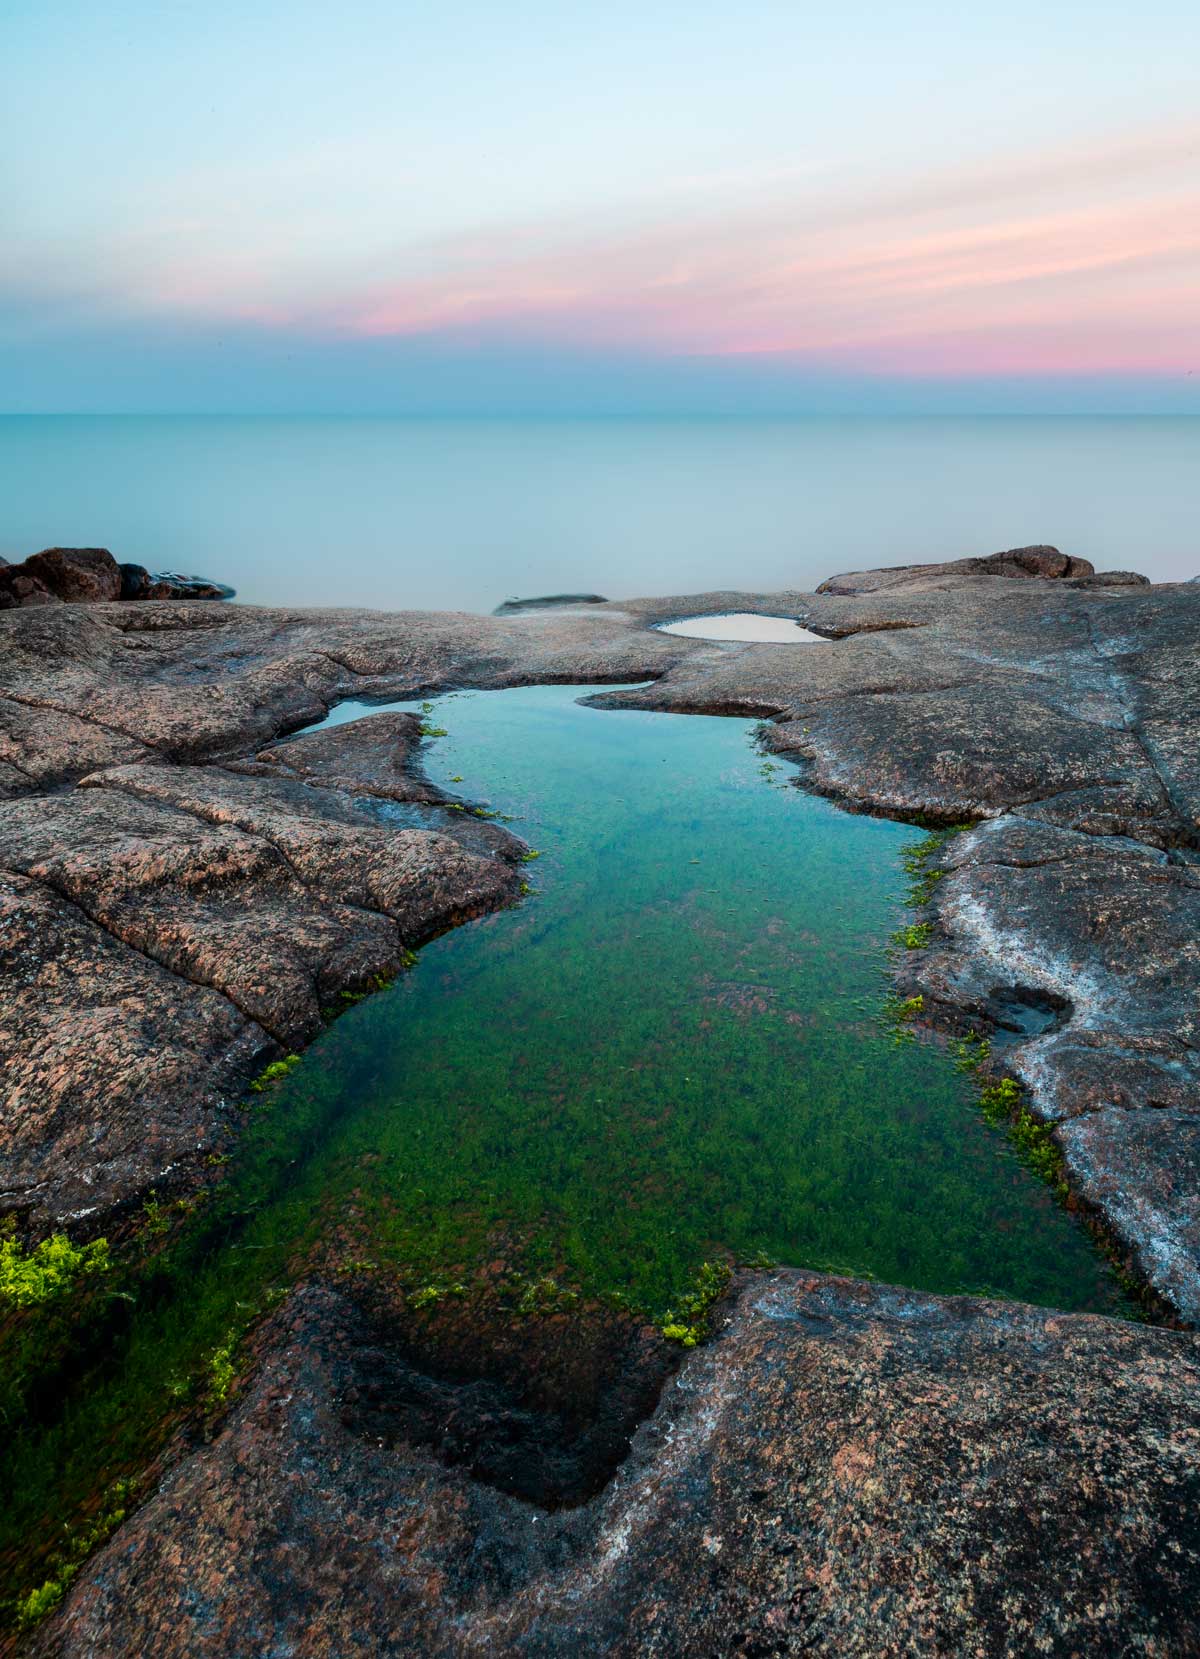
0 687 1129 1608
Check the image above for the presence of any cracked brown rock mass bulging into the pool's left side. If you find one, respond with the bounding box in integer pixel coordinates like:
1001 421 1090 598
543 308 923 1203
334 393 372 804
0 727 521 1226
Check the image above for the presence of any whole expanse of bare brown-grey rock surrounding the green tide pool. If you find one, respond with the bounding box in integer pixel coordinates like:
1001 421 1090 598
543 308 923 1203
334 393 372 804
0 549 1200 1654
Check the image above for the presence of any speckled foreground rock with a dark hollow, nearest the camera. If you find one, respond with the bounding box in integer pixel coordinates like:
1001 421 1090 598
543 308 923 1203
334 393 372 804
35 1272 1200 1659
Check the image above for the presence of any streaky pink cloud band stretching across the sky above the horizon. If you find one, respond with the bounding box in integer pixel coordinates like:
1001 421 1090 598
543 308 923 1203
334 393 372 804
84 126 1200 375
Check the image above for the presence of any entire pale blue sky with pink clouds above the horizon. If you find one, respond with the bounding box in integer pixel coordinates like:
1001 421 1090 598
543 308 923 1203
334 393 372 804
0 0 1200 413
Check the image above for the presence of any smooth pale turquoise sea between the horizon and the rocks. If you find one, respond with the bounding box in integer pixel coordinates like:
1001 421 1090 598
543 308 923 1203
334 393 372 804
0 416 1200 611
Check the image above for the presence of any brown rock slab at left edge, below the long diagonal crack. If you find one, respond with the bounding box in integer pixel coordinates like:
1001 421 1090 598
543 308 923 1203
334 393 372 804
0 873 270 1226
